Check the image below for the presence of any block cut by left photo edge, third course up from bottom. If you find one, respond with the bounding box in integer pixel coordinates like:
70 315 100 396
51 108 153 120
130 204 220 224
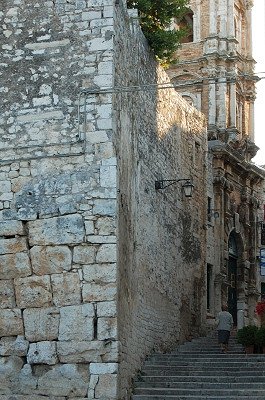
0 309 24 336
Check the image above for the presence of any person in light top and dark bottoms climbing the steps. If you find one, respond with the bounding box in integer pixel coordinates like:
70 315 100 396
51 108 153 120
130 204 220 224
216 304 234 353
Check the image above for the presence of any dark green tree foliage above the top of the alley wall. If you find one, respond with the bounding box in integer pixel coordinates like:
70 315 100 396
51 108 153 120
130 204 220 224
127 0 189 65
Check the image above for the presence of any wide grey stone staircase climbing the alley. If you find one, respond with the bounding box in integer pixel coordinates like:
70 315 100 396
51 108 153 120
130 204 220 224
131 333 265 400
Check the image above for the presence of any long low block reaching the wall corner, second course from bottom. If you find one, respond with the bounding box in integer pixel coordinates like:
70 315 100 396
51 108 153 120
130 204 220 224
57 340 118 363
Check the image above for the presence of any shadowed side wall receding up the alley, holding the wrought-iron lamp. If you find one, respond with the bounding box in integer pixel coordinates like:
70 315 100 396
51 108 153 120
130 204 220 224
114 4 207 399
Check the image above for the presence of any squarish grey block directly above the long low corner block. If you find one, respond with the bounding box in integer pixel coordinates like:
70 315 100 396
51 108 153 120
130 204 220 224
59 304 94 341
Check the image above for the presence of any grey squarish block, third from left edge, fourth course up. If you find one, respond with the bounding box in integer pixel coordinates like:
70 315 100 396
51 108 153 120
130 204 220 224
51 272 81 306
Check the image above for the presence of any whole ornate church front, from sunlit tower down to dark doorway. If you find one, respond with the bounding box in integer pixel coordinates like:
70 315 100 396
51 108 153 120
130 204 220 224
169 0 264 327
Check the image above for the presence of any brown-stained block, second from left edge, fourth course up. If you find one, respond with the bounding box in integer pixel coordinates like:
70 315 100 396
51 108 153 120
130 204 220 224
14 275 52 308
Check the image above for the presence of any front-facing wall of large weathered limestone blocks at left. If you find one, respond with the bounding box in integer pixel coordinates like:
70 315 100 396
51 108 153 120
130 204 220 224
0 0 118 400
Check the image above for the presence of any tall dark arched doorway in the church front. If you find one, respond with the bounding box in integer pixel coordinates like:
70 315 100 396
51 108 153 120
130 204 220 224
227 232 239 325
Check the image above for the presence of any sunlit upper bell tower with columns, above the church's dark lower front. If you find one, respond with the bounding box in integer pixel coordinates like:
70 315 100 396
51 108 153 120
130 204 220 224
168 0 257 160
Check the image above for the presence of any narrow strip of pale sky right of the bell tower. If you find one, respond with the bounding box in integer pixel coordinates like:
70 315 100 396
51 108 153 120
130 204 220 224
252 0 265 165
